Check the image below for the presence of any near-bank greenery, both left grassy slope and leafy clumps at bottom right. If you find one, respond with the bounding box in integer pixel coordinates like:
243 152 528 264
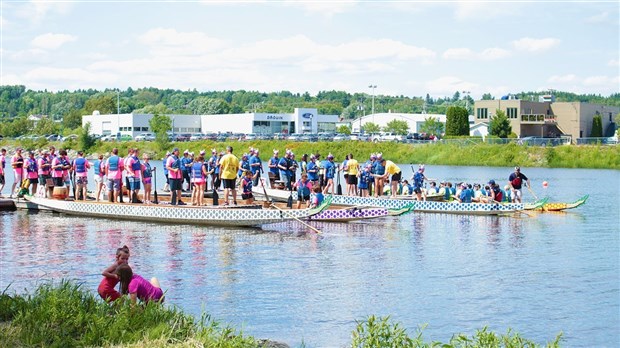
0 281 561 348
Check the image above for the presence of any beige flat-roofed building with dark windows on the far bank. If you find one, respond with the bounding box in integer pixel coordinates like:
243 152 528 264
474 96 620 142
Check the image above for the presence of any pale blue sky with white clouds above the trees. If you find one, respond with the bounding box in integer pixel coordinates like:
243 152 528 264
0 0 620 99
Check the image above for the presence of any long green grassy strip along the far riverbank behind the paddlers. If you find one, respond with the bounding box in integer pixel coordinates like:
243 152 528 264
3 140 620 169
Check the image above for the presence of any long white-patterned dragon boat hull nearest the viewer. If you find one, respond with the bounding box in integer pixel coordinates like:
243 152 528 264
24 196 332 227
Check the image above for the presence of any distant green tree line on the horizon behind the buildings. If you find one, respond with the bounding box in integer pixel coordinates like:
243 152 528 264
0 85 620 137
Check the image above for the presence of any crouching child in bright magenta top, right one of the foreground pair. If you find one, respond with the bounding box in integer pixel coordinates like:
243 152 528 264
116 263 164 303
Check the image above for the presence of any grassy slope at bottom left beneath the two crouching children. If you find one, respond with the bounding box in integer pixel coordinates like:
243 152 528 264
0 281 257 347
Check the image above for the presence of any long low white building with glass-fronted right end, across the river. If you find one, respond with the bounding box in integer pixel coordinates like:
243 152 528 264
82 108 339 137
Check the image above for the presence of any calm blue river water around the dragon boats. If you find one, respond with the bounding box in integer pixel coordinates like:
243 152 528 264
0 165 620 347
